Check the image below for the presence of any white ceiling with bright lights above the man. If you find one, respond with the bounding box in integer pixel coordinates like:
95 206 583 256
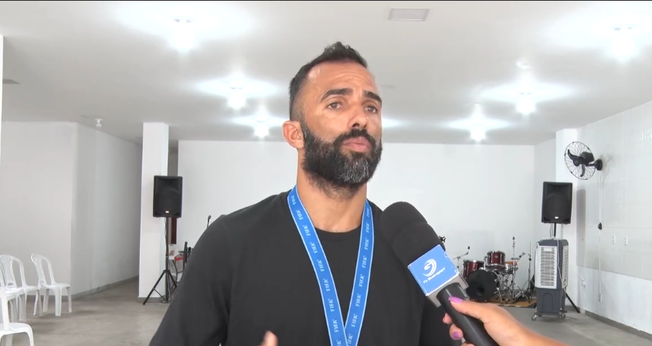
0 1 652 144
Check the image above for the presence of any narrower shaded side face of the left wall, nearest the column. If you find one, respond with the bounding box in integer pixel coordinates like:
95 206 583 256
72 126 141 292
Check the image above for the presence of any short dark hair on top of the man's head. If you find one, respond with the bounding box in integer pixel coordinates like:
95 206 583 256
290 41 367 120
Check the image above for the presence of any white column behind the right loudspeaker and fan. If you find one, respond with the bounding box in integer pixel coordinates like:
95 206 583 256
555 129 579 305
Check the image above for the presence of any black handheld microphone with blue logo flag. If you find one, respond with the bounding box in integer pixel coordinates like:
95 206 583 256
380 202 498 346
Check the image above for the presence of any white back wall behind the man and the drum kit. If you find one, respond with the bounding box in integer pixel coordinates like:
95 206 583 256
178 141 535 284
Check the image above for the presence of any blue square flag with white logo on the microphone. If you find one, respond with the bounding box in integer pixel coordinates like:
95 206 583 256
408 245 459 295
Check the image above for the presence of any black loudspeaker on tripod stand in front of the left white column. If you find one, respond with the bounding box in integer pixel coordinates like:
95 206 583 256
154 175 183 218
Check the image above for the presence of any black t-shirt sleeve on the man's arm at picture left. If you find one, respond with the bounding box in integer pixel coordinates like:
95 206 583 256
149 219 233 346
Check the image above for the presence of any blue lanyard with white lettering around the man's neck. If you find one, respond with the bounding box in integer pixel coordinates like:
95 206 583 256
288 187 374 346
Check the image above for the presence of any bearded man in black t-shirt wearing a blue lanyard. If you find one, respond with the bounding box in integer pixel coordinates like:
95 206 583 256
150 42 452 346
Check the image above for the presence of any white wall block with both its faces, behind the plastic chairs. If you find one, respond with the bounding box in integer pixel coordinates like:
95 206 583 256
0 122 140 294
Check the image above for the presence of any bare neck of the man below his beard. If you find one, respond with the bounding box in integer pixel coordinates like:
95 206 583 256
297 172 367 233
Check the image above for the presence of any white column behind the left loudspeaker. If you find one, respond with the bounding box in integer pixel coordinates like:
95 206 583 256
138 123 169 301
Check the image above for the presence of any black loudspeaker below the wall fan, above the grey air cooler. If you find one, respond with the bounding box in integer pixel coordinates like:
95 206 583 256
541 181 573 225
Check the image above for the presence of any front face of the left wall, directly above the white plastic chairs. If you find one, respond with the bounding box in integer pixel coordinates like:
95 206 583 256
0 122 77 285
